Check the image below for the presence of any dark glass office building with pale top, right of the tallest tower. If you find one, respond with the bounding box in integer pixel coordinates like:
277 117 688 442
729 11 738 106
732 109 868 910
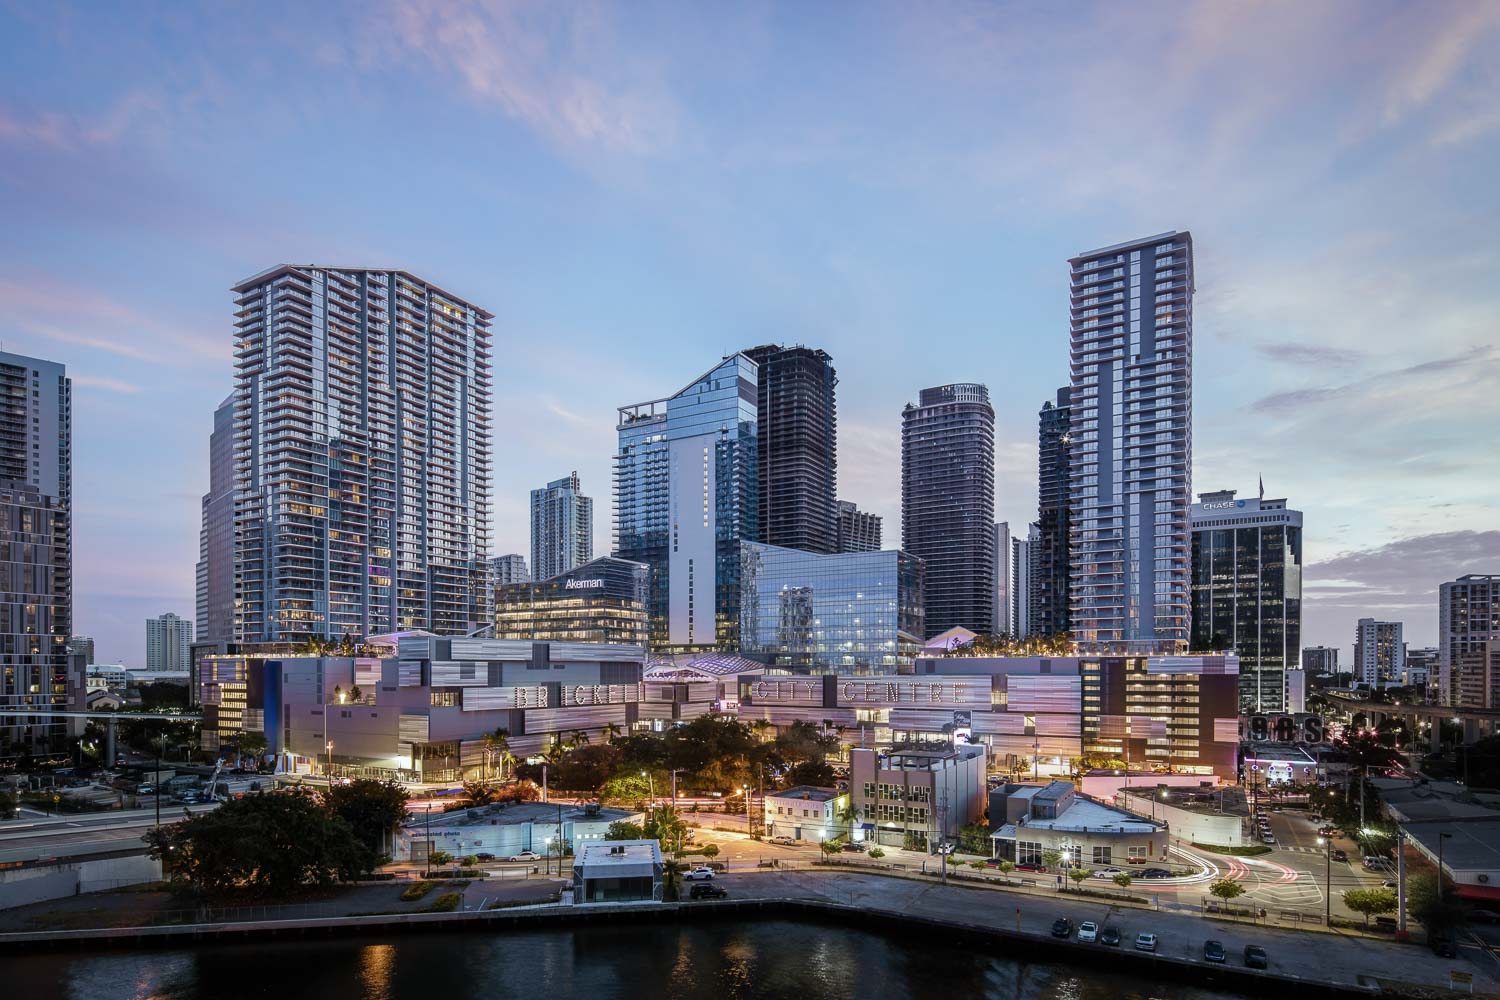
1191 490 1302 714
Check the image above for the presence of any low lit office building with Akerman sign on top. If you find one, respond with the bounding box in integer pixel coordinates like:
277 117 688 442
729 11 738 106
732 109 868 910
495 556 650 646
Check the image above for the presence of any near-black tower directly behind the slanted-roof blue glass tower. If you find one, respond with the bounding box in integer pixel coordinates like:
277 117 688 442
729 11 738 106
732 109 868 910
744 345 839 552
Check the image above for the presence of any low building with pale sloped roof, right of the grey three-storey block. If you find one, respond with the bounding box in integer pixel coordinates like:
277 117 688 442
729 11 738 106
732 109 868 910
990 781 1167 867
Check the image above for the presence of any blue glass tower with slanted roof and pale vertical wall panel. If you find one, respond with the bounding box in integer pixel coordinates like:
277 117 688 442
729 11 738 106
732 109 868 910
615 354 761 652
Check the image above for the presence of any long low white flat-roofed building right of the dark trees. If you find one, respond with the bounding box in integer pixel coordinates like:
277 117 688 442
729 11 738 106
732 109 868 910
393 802 642 864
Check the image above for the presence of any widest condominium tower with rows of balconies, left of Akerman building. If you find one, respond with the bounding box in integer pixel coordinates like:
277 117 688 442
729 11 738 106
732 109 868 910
234 265 492 642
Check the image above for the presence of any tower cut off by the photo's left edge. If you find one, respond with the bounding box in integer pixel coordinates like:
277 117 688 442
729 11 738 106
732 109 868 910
0 352 73 751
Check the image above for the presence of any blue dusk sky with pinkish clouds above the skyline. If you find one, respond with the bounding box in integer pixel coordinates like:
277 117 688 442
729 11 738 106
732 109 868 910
0 0 1500 664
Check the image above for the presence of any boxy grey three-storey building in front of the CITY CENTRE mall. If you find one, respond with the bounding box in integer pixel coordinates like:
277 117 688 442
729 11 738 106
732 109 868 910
849 744 987 852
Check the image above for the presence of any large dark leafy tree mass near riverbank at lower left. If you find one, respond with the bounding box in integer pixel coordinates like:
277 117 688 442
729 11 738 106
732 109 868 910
143 792 374 897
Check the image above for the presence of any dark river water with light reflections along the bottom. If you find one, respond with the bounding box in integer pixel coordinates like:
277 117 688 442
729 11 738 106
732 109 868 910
5 919 1254 1000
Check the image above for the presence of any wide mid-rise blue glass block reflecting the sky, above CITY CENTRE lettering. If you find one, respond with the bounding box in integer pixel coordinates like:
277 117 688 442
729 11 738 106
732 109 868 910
740 541 924 675
